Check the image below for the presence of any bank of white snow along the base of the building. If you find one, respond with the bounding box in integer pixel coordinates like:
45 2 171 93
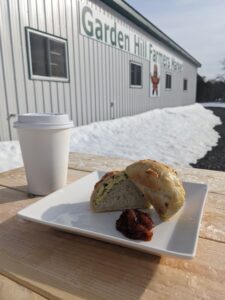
0 104 221 172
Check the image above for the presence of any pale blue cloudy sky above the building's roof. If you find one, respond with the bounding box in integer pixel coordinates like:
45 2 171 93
126 0 225 79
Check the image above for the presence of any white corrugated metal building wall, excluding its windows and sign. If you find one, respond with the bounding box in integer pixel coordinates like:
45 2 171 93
0 0 197 140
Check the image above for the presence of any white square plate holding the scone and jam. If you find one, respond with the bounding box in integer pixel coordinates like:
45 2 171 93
18 171 207 258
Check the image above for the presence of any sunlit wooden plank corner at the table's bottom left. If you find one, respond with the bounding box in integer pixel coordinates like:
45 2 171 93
0 275 47 300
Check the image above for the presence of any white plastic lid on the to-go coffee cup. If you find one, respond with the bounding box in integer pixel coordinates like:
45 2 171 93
13 113 74 129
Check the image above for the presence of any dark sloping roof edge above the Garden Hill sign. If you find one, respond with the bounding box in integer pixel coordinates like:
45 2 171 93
100 0 201 67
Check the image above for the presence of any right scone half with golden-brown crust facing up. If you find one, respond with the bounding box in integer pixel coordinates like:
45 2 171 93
125 160 185 220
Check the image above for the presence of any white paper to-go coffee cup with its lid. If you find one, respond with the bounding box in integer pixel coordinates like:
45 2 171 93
14 114 73 195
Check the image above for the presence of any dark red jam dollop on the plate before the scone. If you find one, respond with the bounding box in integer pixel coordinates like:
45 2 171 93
116 209 154 241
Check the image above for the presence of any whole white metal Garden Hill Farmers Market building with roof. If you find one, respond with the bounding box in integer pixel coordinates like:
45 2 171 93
0 0 200 140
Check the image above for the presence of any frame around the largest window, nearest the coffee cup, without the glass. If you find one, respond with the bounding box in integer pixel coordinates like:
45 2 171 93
25 27 70 82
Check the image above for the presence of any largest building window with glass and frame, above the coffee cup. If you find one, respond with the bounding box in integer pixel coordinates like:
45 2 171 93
26 28 68 81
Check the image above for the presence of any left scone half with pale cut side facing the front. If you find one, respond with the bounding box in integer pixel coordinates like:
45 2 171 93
91 171 149 212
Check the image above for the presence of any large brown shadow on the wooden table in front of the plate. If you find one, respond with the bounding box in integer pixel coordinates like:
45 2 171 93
0 196 160 300
